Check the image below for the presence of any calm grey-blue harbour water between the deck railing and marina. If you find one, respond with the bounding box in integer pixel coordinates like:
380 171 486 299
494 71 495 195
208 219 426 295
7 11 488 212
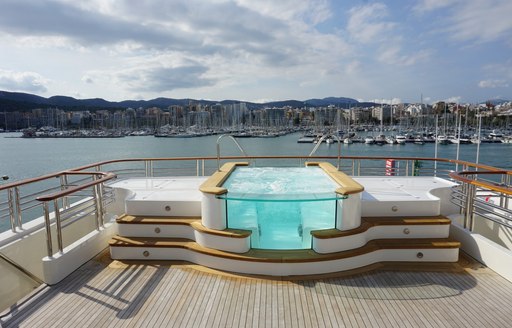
0 133 512 183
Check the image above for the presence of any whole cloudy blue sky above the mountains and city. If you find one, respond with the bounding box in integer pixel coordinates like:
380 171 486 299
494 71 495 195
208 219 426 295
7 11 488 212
0 0 512 103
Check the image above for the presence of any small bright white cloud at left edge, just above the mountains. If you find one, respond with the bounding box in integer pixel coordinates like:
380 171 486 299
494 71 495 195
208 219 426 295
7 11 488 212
0 69 48 92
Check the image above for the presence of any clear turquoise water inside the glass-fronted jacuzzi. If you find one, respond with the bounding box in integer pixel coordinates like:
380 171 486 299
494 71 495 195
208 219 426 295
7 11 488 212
222 167 339 249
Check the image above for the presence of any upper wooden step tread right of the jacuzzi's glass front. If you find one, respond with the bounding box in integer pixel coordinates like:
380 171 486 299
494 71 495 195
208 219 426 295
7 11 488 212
311 215 451 239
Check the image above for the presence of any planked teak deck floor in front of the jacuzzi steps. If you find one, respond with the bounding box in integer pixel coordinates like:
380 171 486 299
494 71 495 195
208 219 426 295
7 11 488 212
0 253 512 327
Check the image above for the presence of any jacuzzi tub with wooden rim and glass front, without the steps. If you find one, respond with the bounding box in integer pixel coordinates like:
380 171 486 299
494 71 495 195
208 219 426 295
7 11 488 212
200 162 364 249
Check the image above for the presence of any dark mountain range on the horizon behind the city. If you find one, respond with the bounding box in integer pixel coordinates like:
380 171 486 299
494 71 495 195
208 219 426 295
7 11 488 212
0 91 364 111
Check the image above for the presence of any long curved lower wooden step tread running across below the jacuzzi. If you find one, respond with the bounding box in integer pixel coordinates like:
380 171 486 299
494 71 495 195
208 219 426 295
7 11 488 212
109 236 460 263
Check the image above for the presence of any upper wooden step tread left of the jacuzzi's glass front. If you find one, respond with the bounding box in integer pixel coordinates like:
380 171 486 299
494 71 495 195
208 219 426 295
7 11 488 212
116 214 252 238
